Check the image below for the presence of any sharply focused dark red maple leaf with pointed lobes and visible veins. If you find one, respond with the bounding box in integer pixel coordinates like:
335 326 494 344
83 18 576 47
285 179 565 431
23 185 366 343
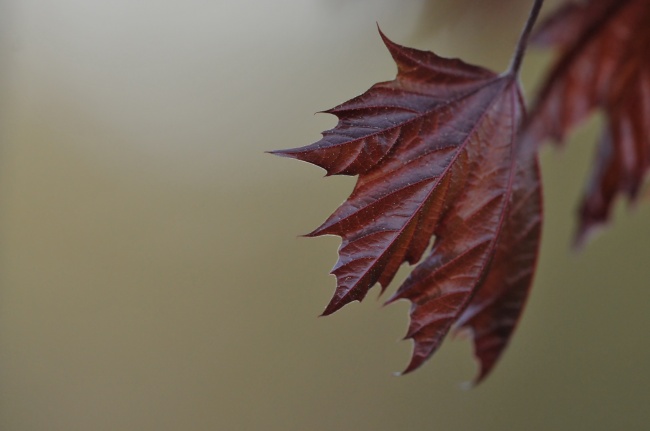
273 26 541 380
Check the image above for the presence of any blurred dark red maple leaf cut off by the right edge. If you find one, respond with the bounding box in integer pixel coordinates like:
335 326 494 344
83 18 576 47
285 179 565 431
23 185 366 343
527 0 650 244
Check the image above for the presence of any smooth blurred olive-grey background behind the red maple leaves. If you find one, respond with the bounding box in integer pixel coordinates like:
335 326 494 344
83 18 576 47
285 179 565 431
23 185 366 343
0 0 650 431
